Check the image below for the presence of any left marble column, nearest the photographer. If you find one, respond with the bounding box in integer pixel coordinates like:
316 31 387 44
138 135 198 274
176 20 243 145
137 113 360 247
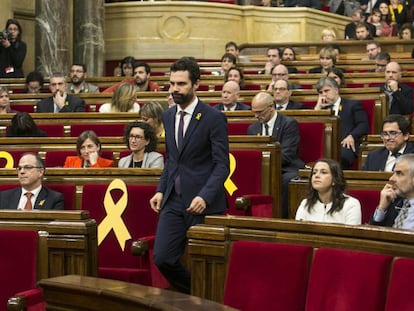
35 0 73 77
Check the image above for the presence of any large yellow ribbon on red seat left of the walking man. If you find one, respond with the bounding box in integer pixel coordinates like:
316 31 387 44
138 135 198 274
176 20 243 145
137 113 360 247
98 179 131 251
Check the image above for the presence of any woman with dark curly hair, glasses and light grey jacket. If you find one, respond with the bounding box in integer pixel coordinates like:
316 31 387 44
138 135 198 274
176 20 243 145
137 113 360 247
118 121 164 168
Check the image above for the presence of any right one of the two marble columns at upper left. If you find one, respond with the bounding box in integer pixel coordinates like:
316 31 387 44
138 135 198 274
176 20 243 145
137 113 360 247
73 0 105 77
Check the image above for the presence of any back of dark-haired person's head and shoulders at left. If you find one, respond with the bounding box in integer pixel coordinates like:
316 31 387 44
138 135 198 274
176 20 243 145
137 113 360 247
6 112 46 137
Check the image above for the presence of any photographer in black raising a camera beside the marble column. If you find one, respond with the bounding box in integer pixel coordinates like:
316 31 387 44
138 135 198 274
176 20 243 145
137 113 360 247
0 19 26 78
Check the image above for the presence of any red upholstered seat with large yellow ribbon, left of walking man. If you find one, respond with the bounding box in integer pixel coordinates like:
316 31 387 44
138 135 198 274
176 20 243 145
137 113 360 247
82 181 168 287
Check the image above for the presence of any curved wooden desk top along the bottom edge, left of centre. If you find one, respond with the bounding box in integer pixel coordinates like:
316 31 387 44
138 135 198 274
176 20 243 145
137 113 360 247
39 275 236 311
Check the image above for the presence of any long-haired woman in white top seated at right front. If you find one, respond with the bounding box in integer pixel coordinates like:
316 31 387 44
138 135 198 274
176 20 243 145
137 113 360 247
295 159 362 225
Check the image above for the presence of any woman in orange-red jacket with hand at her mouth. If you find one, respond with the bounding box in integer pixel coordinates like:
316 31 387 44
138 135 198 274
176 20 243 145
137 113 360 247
64 131 114 168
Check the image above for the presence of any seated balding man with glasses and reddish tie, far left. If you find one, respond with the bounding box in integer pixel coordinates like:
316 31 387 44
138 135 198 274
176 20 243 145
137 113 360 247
0 153 64 210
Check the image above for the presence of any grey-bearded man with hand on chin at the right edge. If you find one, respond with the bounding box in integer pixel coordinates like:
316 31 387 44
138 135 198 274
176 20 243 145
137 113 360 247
370 154 414 230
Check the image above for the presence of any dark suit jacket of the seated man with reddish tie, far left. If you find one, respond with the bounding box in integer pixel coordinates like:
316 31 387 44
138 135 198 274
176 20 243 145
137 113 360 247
0 187 65 210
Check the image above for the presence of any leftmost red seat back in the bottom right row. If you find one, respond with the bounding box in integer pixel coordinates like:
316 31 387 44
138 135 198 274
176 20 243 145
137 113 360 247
224 241 313 311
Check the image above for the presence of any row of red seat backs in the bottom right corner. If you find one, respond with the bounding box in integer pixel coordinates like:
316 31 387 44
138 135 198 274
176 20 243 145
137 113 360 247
224 241 414 311
